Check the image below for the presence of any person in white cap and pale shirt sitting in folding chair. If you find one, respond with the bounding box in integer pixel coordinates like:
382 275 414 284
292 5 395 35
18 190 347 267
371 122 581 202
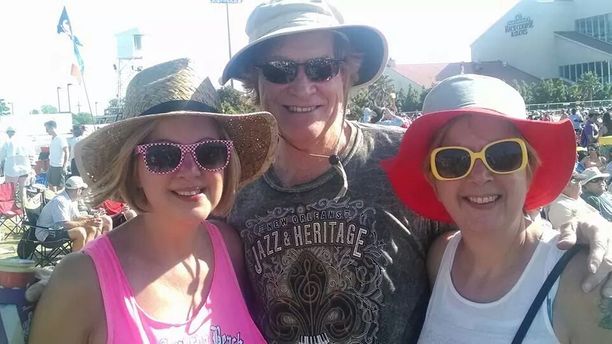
35 176 108 252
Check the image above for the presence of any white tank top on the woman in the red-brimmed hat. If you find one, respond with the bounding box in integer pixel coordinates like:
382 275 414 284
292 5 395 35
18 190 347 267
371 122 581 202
419 221 564 344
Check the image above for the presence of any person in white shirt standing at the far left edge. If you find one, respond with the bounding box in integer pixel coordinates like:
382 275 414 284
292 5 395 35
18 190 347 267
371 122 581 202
0 127 34 204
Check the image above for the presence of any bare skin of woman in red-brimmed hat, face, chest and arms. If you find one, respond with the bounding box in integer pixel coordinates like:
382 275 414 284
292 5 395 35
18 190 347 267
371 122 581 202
428 115 612 343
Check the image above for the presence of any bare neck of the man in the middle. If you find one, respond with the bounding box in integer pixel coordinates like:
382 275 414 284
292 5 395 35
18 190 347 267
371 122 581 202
273 122 352 187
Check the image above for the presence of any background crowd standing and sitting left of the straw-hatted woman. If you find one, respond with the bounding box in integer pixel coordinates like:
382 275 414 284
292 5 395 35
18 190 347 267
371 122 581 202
0 121 136 251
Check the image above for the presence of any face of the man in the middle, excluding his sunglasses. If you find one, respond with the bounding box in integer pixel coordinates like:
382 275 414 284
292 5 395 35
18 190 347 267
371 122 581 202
258 32 344 150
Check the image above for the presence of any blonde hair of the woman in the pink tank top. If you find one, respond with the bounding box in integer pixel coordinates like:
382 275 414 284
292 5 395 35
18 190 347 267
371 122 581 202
91 118 241 216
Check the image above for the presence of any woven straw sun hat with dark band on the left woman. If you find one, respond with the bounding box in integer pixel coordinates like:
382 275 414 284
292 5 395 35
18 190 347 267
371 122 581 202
75 59 278 186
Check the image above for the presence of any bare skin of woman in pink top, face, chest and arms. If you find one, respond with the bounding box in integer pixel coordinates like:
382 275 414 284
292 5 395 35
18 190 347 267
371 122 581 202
32 116 249 343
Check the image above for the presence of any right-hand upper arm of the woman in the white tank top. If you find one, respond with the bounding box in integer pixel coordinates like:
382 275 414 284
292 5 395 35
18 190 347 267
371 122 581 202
553 250 612 343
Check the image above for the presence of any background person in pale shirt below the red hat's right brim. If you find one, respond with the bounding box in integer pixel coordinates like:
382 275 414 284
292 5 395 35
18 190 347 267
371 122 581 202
546 172 605 228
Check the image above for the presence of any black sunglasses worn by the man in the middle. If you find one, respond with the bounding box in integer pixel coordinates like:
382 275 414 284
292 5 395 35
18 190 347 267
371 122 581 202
255 57 344 84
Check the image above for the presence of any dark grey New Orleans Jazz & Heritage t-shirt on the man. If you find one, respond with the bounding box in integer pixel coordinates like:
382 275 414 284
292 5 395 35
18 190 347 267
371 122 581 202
229 123 438 344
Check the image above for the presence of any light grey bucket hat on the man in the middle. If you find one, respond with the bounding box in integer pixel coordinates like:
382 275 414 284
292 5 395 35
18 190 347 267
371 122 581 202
220 0 388 86
